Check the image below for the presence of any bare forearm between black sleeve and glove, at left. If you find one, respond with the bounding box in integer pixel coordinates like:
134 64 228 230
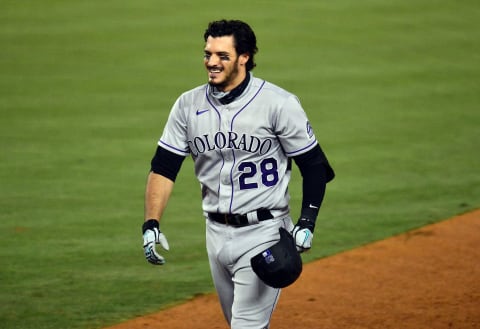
145 172 174 221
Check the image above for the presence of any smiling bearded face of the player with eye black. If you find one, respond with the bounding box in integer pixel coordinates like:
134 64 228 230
203 36 249 91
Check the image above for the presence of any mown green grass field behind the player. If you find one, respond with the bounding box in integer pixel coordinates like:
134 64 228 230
0 0 480 329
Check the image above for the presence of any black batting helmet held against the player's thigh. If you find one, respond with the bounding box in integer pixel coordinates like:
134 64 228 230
250 227 302 288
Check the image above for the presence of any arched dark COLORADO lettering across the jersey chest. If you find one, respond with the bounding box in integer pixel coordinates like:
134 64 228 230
188 131 273 156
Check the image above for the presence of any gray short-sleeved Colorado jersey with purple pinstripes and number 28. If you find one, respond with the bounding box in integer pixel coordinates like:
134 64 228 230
159 73 317 214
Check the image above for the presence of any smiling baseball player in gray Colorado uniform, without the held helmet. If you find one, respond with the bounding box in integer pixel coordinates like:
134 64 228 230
143 20 334 329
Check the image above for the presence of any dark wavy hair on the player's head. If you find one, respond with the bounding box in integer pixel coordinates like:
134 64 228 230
203 19 258 71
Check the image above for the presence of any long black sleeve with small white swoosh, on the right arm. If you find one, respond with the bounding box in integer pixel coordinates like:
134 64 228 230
293 145 335 223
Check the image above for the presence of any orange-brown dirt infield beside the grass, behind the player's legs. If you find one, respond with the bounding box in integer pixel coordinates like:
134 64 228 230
106 210 480 329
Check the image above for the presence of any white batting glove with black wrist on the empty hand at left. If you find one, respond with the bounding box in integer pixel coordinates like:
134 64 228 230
142 219 170 265
